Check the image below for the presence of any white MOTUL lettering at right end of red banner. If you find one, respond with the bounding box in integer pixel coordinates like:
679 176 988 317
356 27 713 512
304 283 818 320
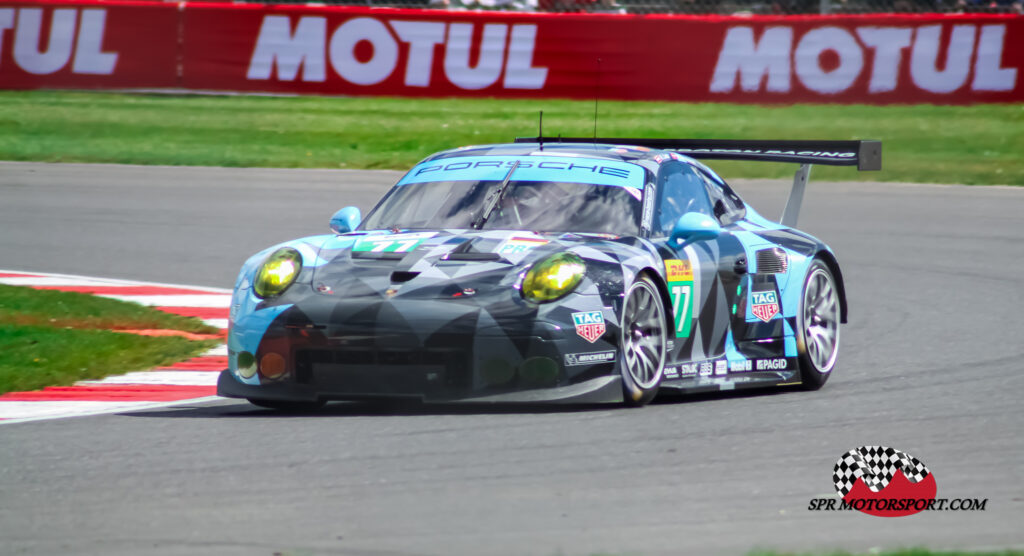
710 25 1017 94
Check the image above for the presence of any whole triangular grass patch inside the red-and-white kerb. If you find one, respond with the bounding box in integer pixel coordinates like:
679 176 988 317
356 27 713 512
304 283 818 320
0 286 219 394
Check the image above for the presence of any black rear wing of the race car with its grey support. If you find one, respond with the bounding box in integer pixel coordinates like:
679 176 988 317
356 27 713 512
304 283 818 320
515 137 882 226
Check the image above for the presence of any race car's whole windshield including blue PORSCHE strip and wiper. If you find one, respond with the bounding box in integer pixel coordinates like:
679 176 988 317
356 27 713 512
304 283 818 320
360 157 644 236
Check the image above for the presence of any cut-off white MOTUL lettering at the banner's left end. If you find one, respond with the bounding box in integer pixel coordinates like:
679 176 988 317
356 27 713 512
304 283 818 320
0 8 118 75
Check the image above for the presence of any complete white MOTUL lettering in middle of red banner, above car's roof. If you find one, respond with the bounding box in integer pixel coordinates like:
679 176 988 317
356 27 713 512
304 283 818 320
247 15 548 90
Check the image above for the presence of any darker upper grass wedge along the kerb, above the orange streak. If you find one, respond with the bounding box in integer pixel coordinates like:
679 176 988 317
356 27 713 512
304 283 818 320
0 285 217 334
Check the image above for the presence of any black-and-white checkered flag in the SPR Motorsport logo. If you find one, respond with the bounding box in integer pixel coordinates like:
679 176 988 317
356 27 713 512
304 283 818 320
833 446 929 497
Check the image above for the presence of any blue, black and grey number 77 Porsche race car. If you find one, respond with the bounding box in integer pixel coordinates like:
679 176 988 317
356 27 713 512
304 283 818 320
217 137 882 409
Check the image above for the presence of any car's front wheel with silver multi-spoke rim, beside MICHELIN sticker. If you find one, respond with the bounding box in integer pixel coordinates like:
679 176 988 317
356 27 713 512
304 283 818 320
618 276 666 405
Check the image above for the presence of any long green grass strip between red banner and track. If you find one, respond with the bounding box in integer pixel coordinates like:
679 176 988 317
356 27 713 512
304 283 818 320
0 91 1024 185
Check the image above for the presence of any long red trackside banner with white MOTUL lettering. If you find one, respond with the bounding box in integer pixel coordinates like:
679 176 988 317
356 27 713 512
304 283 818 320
0 0 1024 104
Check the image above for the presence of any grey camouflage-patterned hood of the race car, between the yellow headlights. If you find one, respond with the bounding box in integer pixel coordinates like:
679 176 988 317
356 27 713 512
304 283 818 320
312 229 615 298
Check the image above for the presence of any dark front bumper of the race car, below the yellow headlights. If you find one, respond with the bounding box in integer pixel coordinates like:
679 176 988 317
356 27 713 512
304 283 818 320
218 297 622 402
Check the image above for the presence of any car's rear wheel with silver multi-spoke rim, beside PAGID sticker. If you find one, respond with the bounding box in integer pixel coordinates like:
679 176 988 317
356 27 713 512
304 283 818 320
797 259 842 390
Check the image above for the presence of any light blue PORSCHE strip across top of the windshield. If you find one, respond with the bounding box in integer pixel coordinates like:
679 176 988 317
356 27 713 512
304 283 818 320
398 156 644 189
